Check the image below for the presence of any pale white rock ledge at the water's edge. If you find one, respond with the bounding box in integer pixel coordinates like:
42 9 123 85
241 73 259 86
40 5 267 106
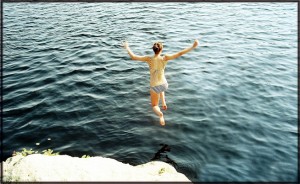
3 154 190 182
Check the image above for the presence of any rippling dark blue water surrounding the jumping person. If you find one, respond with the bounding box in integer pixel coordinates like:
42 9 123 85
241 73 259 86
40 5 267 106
3 3 298 181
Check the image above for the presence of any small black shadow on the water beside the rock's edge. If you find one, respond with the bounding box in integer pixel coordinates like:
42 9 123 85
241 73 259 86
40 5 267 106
151 144 178 169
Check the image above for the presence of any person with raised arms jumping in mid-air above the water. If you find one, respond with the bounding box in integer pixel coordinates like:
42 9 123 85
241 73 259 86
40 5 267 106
123 40 199 126
